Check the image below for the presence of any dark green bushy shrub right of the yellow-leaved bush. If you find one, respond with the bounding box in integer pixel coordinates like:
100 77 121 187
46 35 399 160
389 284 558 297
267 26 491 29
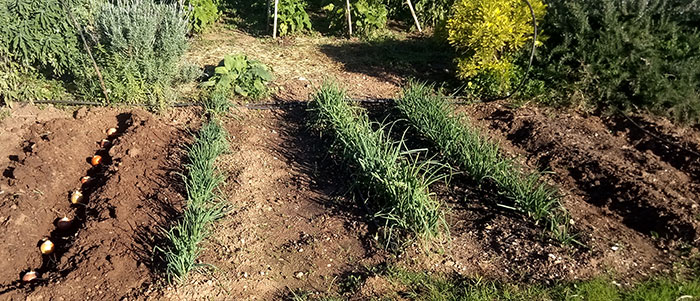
541 0 700 123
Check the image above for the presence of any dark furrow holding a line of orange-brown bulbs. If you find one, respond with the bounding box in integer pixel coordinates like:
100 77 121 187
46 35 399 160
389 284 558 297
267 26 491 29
17 128 120 286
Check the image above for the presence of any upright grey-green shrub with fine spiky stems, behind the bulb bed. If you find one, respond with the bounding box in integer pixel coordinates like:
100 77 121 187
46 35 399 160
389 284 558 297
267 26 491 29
91 0 189 107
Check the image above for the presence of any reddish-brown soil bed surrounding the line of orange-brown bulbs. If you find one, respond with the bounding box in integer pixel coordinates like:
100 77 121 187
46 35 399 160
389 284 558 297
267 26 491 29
0 108 201 300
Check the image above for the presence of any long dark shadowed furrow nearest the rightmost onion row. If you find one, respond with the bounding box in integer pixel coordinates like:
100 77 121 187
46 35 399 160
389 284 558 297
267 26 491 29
493 111 697 241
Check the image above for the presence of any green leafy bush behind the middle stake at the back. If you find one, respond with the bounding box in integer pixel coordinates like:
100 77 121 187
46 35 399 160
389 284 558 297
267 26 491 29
323 0 388 38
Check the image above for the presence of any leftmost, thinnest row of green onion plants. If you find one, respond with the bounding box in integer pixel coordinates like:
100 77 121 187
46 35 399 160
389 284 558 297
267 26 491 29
159 120 228 283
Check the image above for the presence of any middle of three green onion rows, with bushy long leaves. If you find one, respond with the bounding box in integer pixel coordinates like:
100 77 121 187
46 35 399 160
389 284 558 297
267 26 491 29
309 82 447 243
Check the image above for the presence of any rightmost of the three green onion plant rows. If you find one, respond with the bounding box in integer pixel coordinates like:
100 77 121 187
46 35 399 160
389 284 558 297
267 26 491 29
396 83 573 243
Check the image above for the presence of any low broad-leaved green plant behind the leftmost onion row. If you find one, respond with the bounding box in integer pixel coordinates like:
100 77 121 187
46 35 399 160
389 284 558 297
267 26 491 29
202 54 272 111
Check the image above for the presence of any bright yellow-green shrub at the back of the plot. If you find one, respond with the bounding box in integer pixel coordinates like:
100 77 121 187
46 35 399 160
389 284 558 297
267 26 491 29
447 0 546 91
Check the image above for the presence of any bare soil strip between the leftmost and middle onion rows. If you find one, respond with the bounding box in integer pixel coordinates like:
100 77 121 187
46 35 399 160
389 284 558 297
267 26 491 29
162 108 383 300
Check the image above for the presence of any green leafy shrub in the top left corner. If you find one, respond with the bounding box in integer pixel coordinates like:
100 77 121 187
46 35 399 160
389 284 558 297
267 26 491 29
0 0 90 102
